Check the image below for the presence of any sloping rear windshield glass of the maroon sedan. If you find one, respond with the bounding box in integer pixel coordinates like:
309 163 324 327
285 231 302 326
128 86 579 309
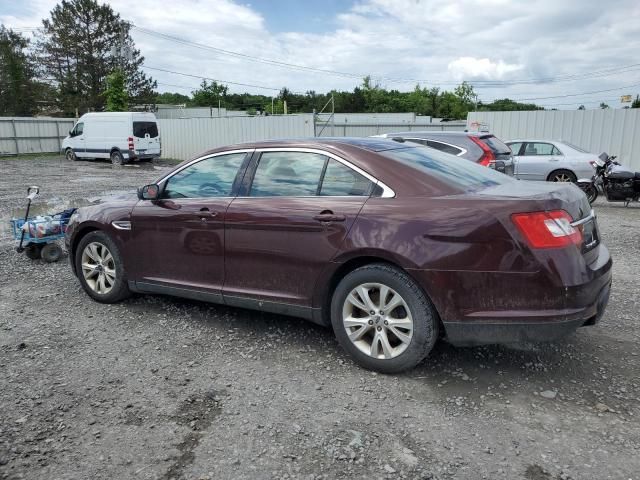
380 147 514 192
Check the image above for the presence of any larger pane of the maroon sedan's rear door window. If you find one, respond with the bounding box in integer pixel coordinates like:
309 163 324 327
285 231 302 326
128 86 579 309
249 152 327 197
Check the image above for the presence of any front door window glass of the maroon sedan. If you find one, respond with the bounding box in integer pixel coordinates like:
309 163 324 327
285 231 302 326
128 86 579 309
162 153 247 198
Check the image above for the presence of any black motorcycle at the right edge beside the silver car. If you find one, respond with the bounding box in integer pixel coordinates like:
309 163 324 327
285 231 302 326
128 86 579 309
577 152 640 207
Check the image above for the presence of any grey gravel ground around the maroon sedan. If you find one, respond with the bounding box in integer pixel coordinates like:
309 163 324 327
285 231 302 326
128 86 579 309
0 157 640 480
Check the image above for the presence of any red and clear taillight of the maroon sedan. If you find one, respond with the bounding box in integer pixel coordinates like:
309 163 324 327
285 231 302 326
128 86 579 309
511 210 582 248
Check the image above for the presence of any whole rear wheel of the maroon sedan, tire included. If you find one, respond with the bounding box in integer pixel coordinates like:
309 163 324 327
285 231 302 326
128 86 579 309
331 264 438 373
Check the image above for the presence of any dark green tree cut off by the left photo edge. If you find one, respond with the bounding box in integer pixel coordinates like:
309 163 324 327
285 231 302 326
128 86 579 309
0 25 46 116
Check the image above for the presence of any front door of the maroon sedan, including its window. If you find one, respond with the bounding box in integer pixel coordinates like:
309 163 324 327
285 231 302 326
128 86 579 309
130 151 250 300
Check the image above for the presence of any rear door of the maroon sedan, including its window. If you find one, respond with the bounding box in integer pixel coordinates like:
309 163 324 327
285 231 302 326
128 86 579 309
224 149 375 316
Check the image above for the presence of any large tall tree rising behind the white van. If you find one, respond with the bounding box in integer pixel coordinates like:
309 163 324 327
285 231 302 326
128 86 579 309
37 0 157 114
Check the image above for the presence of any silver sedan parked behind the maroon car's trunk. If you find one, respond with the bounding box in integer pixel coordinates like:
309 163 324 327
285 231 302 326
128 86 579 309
506 140 598 183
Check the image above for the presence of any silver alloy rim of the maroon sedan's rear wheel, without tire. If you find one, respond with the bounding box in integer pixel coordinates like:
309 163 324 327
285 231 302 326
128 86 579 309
342 283 413 360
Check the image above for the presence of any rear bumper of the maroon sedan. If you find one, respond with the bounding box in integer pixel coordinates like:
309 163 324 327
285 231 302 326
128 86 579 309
416 244 612 345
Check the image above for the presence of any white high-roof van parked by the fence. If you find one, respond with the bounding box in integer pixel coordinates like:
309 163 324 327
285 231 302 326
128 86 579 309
62 112 161 164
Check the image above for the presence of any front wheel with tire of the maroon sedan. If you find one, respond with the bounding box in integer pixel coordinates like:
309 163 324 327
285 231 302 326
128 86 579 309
74 231 131 303
